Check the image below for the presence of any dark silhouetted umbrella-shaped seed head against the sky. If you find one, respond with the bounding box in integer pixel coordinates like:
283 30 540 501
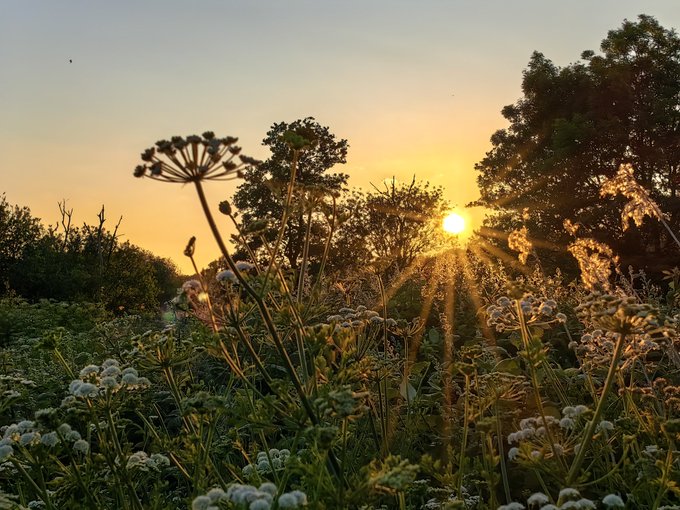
134 131 260 184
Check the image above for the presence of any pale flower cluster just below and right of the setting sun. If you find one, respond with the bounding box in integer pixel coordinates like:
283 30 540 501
486 294 567 332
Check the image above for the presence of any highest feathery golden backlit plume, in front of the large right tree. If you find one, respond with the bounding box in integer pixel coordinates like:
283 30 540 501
600 163 666 230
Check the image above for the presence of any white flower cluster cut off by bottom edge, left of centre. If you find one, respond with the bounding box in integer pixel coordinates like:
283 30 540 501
191 482 307 510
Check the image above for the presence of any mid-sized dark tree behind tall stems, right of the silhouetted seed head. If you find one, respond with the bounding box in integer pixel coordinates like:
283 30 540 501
233 117 348 269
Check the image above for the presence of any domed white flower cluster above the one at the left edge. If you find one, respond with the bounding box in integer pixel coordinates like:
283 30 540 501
64 359 151 404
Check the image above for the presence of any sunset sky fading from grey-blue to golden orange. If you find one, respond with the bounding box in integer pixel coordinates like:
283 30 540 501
0 0 680 273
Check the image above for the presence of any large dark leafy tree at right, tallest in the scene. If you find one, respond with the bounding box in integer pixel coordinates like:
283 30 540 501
474 15 680 270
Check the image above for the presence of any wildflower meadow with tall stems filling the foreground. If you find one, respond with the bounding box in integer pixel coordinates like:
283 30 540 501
0 124 680 510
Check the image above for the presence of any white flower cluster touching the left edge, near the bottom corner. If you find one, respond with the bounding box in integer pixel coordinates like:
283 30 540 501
0 418 90 463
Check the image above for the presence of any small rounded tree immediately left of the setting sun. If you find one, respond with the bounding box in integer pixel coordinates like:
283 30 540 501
332 176 448 275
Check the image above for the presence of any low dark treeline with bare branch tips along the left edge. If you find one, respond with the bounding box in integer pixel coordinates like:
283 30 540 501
0 194 181 313
